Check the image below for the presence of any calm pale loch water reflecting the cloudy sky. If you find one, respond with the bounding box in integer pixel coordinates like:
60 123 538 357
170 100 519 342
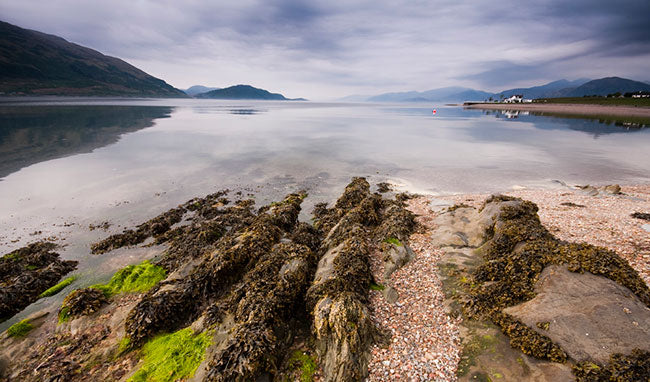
0 100 650 326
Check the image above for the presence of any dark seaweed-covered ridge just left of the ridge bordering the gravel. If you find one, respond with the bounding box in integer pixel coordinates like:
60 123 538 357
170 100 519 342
206 243 316 381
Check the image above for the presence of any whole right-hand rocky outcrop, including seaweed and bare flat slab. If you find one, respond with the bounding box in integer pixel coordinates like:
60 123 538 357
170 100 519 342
434 196 650 381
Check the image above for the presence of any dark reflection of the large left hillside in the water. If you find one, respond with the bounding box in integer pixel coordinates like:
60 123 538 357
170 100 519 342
0 106 172 179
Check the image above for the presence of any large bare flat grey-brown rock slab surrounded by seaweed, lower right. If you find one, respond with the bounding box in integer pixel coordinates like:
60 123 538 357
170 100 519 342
504 265 650 363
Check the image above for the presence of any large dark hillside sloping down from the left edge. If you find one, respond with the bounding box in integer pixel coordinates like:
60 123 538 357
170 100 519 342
0 21 187 97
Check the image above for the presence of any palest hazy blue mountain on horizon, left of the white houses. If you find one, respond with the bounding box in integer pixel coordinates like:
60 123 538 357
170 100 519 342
366 86 493 102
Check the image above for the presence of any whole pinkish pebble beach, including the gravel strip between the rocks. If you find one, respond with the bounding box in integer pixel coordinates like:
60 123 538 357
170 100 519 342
368 184 650 381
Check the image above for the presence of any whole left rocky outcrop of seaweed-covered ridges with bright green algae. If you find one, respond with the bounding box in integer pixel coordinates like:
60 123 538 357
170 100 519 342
0 178 415 381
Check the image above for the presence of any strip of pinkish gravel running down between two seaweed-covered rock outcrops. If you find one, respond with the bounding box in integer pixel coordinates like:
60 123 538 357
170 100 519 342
368 199 460 381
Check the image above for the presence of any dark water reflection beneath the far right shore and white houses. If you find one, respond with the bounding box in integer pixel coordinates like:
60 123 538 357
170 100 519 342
484 110 650 138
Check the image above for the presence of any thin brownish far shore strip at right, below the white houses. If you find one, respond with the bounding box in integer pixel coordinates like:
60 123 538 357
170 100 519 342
464 103 650 118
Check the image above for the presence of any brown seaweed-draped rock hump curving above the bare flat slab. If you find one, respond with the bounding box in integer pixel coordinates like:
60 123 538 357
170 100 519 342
471 200 650 312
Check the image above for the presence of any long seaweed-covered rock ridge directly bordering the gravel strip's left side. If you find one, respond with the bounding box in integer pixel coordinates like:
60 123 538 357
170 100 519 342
307 178 415 381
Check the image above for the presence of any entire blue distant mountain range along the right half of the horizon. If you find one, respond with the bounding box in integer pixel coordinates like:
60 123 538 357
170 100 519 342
341 77 650 102
